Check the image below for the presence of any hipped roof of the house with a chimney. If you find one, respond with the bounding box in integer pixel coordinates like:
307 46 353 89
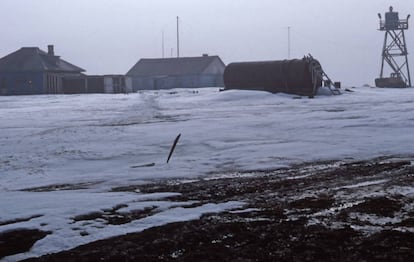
0 47 85 73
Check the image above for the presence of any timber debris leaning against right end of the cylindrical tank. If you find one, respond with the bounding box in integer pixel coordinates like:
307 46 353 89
304 54 341 95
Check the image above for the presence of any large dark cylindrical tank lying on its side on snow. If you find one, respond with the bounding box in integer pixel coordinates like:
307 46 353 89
223 58 322 97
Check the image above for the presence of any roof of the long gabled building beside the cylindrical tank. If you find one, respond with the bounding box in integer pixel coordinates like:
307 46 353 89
127 56 225 76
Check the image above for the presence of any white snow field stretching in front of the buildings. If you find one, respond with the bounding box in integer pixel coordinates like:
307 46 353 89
0 87 414 261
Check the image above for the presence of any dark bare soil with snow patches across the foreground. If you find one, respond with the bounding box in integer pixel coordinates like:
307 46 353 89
5 158 414 261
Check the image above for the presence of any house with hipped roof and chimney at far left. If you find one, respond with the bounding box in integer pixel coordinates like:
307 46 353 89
0 45 85 95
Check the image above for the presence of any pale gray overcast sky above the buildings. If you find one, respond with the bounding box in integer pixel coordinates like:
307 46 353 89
0 0 414 85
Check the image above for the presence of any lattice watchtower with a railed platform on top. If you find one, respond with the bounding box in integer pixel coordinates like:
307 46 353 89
375 6 411 87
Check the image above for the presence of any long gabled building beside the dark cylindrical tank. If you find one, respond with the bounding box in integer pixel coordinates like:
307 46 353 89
126 55 226 91
